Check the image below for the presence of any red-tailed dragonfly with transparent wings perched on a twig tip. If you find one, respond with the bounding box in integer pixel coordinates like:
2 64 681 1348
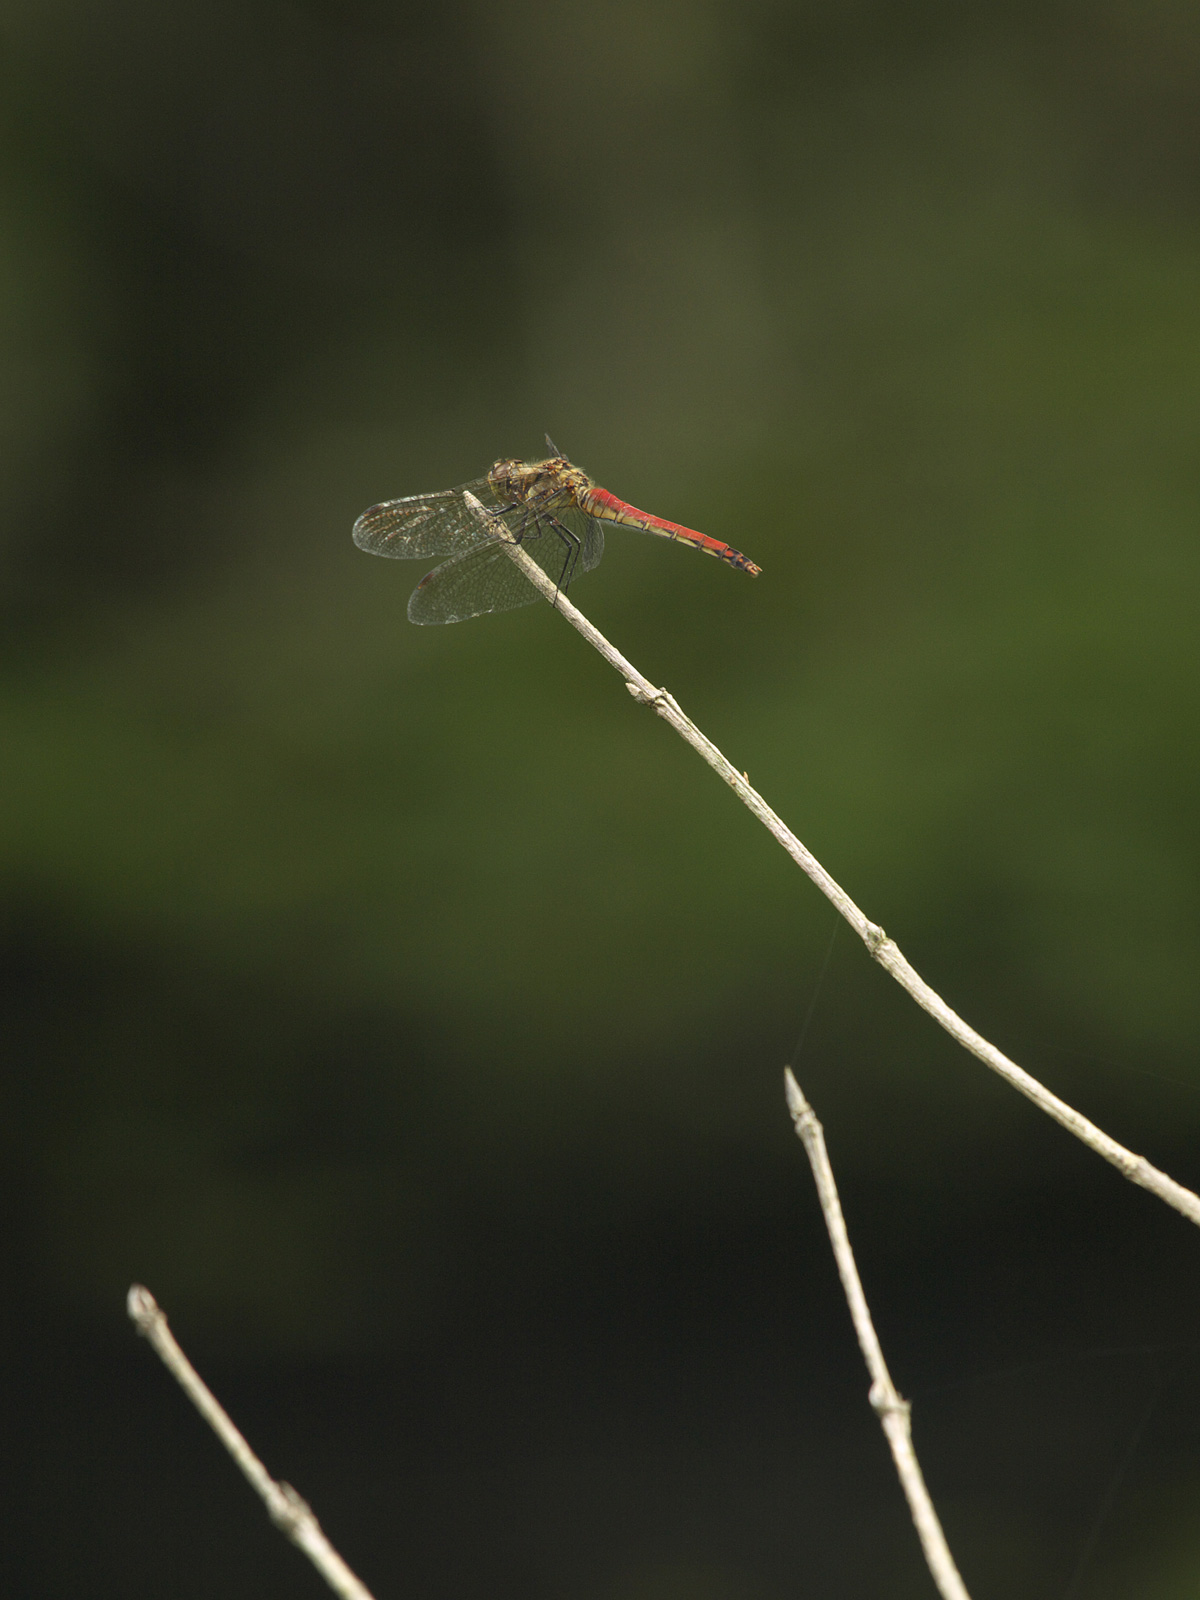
354 435 762 624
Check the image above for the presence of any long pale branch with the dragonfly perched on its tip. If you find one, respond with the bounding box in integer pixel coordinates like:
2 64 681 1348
466 494 1200 1226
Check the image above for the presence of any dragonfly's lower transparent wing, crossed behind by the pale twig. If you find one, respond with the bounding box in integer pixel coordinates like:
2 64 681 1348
408 512 605 624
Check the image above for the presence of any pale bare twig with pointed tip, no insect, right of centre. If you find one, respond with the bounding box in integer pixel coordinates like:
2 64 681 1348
784 1067 971 1600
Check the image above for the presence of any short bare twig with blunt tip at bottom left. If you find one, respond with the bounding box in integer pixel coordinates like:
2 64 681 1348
125 1283 371 1600
